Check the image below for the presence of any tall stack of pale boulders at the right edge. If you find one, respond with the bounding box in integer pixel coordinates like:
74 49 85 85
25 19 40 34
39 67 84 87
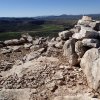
63 16 100 94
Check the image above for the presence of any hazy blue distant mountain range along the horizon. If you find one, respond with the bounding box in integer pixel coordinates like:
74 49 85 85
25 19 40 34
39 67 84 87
0 14 100 21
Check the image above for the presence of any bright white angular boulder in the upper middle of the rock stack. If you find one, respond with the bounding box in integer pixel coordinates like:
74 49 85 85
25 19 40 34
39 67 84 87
72 26 99 39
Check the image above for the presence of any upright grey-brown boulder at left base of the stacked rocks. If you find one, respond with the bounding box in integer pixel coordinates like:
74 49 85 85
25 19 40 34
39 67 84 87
63 39 78 65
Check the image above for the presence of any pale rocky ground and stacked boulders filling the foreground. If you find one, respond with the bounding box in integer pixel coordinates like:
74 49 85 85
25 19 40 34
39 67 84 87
0 16 100 100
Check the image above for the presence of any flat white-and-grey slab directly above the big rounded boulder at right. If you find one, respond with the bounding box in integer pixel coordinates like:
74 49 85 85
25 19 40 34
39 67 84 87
82 39 100 48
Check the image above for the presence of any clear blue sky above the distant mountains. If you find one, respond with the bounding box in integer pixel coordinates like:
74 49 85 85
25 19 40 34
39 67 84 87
0 0 100 17
